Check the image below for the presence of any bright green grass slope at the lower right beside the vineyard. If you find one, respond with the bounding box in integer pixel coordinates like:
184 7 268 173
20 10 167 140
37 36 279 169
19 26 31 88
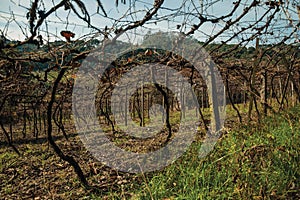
101 107 300 199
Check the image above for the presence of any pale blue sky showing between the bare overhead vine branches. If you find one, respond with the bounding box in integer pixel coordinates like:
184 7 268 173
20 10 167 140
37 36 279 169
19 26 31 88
0 0 299 45
